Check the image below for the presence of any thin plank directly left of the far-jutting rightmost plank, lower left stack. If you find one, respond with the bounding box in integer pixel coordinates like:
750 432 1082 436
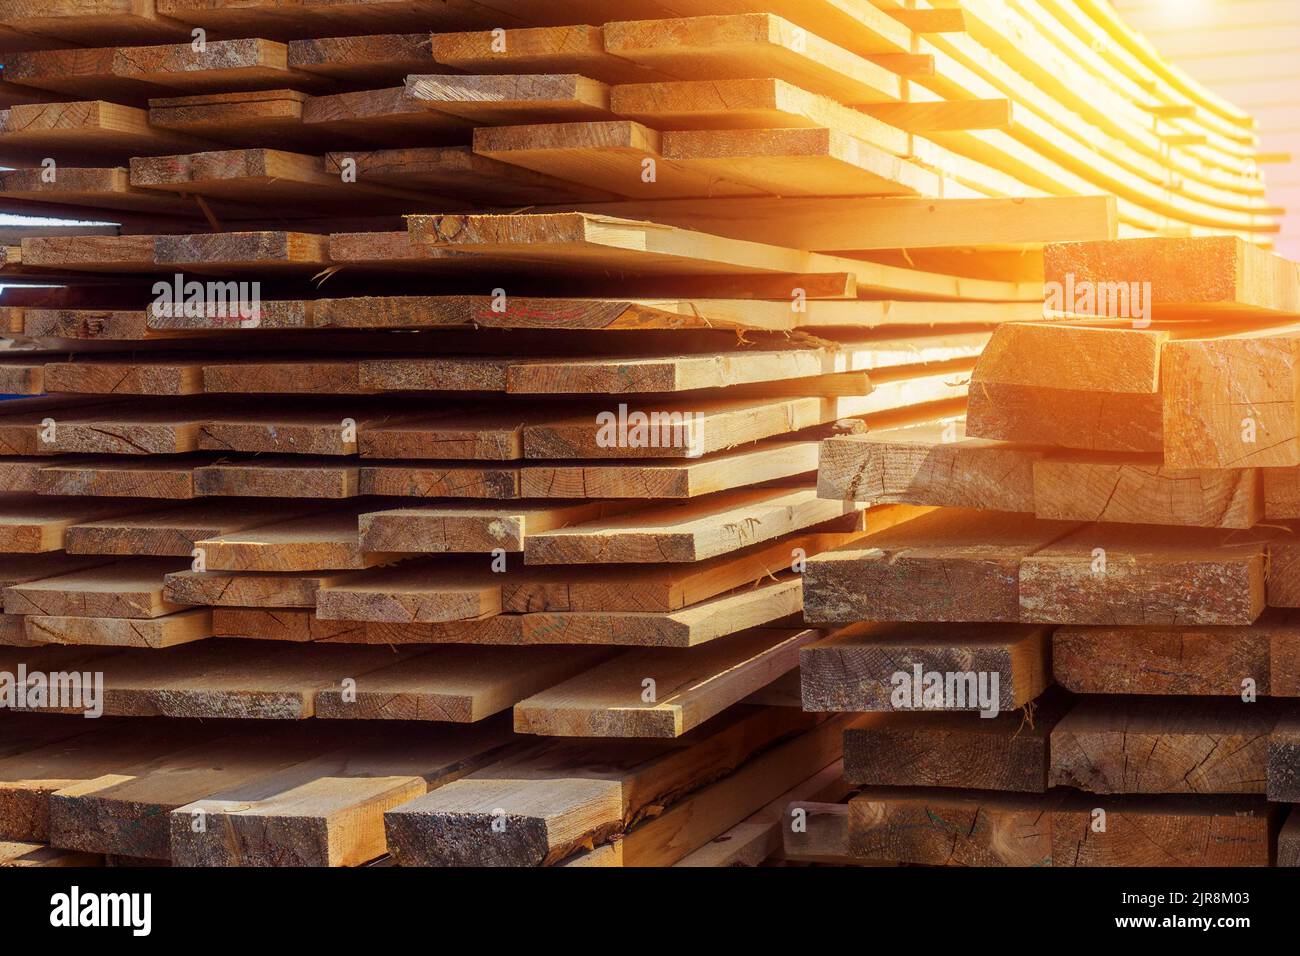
316 646 607 723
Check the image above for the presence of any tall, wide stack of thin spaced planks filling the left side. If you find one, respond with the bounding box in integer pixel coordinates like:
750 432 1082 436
0 0 1279 866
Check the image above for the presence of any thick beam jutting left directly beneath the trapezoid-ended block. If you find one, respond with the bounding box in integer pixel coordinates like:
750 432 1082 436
818 420 1040 518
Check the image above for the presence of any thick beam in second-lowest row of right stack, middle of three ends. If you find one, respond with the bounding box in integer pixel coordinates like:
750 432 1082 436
1049 697 1279 793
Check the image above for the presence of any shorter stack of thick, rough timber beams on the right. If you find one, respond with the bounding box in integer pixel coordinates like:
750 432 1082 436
793 237 1300 866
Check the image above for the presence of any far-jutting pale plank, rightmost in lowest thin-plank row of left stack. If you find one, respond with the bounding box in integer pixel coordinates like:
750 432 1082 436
515 628 819 737
